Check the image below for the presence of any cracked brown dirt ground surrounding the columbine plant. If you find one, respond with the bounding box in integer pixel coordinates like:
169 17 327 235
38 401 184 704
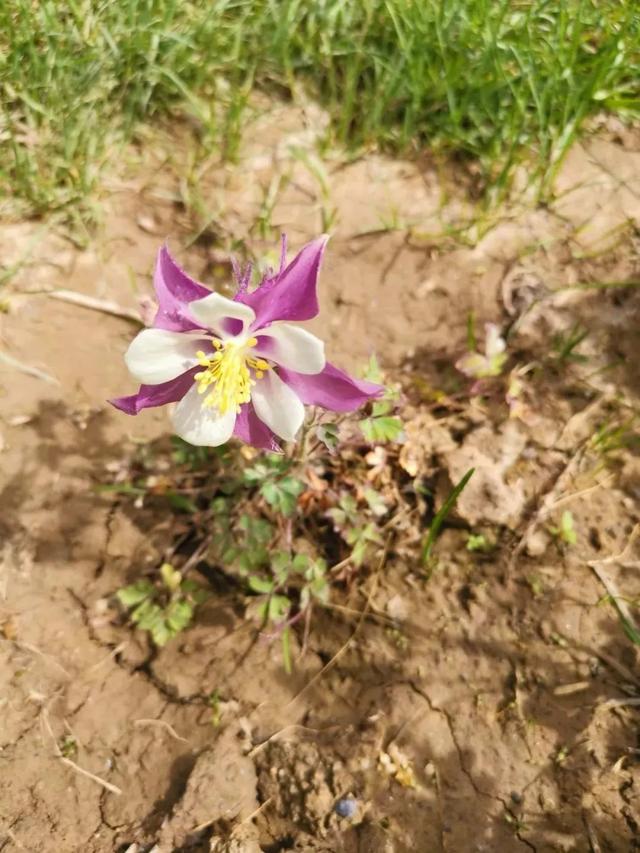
0 107 640 853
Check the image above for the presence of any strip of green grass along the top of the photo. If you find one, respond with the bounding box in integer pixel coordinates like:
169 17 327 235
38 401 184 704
0 0 640 220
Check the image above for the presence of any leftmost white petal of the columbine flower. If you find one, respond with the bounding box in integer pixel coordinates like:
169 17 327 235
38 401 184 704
124 329 202 385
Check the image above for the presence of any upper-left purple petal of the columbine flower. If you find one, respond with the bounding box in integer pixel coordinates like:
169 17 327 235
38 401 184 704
153 246 211 332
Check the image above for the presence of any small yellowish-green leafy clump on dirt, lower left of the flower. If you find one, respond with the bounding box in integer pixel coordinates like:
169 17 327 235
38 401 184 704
116 563 207 646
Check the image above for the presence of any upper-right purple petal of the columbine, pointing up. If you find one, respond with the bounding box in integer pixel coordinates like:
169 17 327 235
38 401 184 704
236 235 329 329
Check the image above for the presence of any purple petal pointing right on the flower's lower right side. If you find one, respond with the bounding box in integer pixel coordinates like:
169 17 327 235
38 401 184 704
278 362 384 412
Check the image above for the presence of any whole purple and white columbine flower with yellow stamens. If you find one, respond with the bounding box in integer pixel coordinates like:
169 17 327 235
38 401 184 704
111 237 383 451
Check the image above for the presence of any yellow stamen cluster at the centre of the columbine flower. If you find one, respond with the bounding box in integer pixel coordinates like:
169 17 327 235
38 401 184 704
193 338 270 415
